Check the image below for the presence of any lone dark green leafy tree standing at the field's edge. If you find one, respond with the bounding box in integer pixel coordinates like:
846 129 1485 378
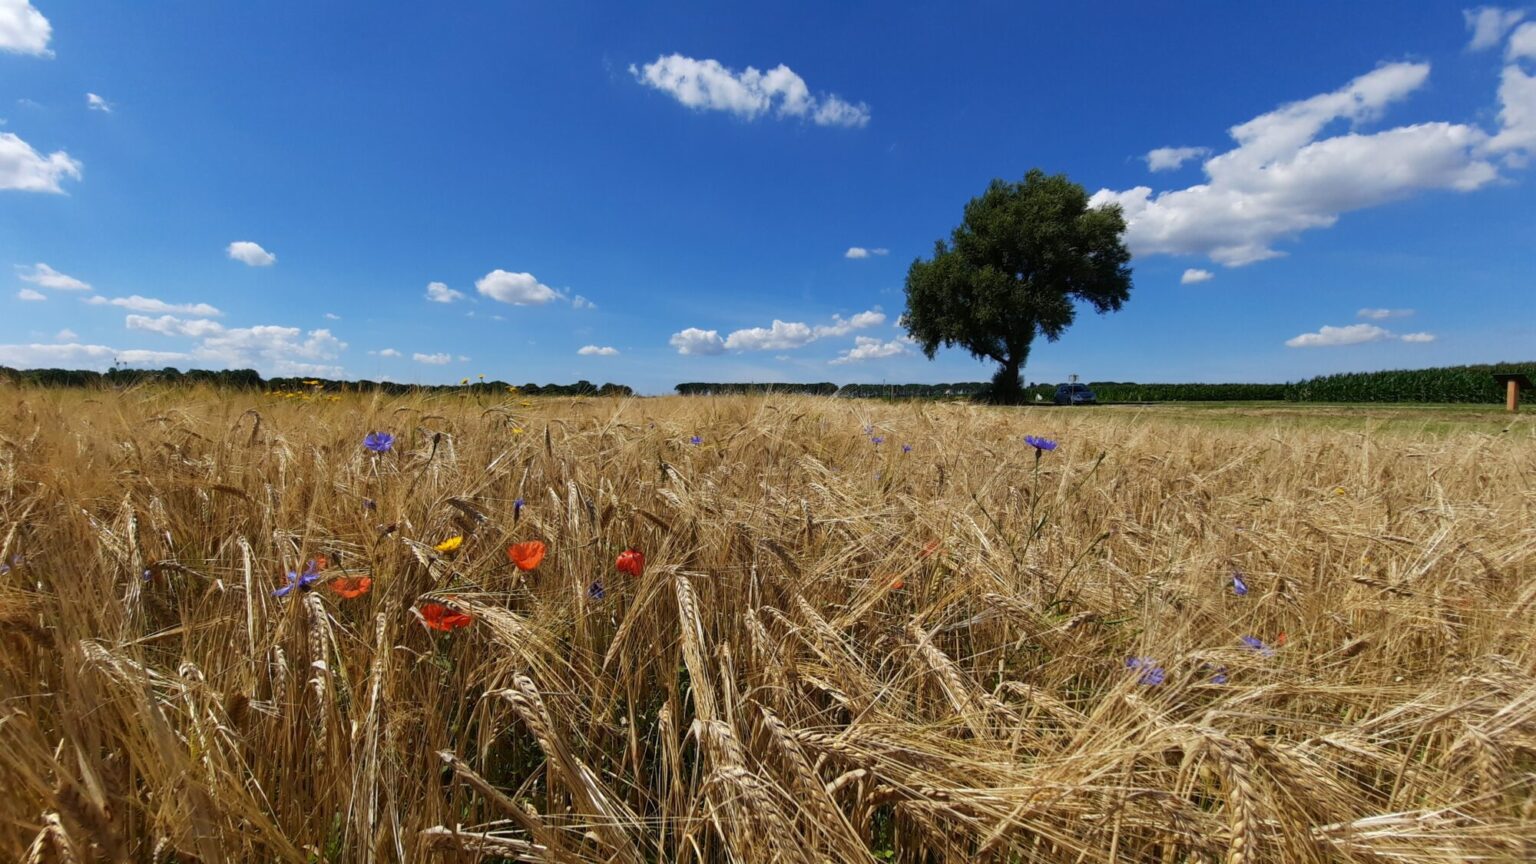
902 168 1130 404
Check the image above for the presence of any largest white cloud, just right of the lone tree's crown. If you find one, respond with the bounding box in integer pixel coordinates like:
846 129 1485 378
1092 63 1498 268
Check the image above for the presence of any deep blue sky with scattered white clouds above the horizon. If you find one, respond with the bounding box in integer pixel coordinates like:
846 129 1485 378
0 0 1536 392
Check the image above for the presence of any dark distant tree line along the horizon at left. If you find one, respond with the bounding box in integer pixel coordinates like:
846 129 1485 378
0 366 634 397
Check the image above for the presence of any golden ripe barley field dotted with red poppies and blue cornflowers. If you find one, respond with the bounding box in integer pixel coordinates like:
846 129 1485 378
0 386 1536 864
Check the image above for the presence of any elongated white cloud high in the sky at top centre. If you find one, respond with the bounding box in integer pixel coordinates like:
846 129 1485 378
630 54 869 128
